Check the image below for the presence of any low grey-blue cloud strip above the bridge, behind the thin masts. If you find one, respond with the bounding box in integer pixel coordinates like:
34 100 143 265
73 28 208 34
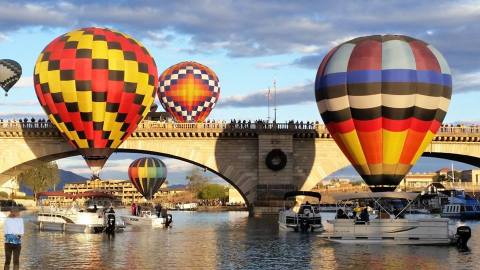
218 83 315 108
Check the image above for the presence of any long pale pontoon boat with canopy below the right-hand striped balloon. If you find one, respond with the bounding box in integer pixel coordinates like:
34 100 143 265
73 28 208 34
319 192 471 248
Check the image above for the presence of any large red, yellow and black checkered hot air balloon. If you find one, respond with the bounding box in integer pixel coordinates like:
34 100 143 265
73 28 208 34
34 27 158 175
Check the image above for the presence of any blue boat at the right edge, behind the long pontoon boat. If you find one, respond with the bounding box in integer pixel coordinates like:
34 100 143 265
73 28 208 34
440 190 480 220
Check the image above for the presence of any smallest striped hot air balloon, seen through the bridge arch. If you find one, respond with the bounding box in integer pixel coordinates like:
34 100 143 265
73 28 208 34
128 157 167 200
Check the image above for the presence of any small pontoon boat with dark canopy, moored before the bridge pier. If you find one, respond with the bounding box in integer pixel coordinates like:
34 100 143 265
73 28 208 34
278 191 323 232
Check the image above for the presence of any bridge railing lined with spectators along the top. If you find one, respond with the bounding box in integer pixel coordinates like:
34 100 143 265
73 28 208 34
0 120 480 136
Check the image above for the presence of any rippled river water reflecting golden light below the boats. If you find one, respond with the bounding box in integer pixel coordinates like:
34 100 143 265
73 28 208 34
0 212 480 270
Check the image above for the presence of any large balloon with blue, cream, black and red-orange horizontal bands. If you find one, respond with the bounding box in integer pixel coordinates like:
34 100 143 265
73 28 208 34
315 35 452 191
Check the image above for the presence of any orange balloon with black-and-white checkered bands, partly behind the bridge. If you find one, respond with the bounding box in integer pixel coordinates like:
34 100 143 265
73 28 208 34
158 62 220 123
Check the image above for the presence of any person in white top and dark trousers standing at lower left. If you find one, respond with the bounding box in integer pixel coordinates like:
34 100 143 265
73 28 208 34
3 208 24 269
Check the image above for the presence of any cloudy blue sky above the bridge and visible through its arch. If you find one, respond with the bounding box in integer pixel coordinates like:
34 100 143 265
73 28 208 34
0 0 480 186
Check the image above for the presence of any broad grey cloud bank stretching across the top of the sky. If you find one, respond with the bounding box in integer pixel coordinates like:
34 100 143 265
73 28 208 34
0 0 472 73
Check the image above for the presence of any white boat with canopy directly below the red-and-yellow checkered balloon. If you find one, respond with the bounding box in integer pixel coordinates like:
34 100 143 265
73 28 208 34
34 192 125 233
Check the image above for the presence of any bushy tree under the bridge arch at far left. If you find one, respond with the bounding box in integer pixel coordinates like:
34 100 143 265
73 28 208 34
17 162 60 197
